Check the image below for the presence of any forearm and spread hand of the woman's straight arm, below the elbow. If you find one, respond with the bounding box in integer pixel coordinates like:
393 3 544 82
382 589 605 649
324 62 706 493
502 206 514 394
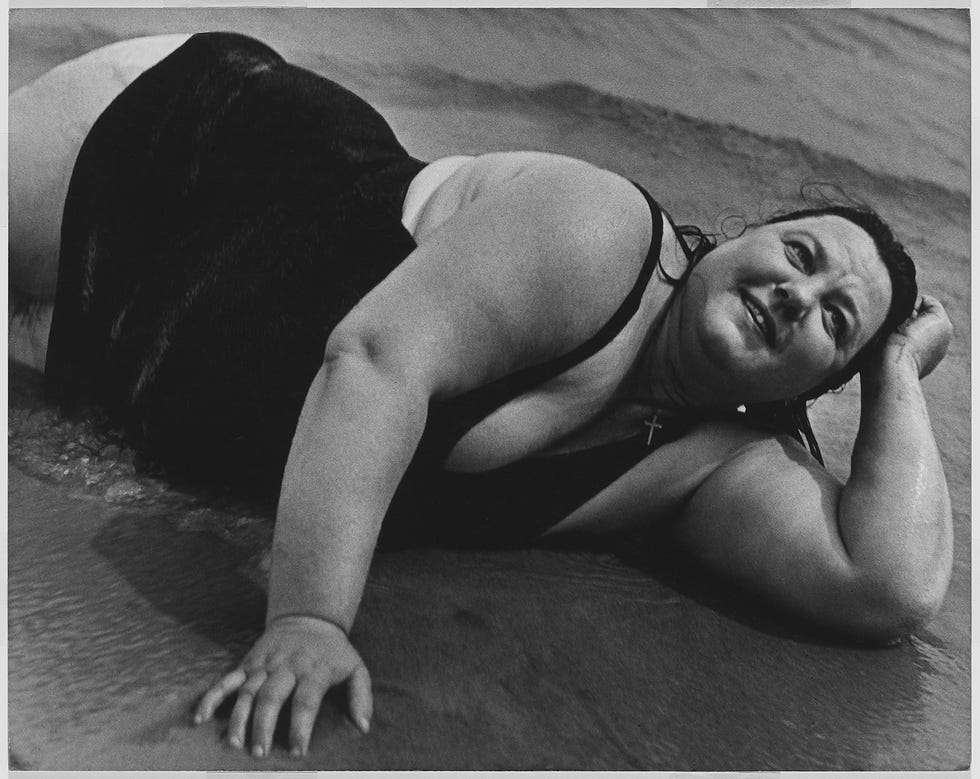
198 339 429 756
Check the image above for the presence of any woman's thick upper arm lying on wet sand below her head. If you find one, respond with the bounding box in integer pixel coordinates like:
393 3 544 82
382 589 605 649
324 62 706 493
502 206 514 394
678 436 916 636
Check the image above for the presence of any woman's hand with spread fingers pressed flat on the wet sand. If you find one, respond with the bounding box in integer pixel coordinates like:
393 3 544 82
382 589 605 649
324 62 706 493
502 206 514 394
194 616 373 757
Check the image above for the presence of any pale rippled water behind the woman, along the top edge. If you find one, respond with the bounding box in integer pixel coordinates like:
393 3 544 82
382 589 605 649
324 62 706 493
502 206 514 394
11 9 970 192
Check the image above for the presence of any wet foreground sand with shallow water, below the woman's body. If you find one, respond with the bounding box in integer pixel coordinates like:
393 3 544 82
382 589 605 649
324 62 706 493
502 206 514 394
8 362 969 771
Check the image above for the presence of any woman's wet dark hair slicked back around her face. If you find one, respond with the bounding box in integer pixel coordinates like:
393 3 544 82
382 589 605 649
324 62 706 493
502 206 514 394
660 193 919 465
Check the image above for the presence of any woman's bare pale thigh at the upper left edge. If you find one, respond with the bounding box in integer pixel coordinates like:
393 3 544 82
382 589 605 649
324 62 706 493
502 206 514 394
8 34 189 300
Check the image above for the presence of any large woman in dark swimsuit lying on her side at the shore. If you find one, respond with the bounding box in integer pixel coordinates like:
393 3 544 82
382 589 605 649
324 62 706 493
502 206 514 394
10 34 952 754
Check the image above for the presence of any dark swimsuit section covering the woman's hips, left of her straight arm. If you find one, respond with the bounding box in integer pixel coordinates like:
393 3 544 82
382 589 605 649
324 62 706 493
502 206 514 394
46 34 424 484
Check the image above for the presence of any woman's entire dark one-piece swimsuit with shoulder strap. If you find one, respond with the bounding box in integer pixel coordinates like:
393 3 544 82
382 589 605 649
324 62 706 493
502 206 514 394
46 33 684 547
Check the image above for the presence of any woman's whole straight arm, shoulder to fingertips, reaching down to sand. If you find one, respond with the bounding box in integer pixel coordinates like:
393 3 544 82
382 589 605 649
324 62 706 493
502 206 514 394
190 163 650 754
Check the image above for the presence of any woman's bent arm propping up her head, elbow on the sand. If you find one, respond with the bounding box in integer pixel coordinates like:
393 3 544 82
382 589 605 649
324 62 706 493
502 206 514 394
679 298 952 638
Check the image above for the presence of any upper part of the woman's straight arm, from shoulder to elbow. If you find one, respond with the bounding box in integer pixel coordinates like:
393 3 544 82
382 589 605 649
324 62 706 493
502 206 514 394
327 161 651 397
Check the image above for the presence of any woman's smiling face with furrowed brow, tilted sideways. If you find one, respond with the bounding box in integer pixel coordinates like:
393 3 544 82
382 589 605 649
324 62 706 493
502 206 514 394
681 215 891 403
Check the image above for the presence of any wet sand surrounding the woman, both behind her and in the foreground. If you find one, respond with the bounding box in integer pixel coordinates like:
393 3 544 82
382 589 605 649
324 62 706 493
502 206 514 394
8 12 970 770
